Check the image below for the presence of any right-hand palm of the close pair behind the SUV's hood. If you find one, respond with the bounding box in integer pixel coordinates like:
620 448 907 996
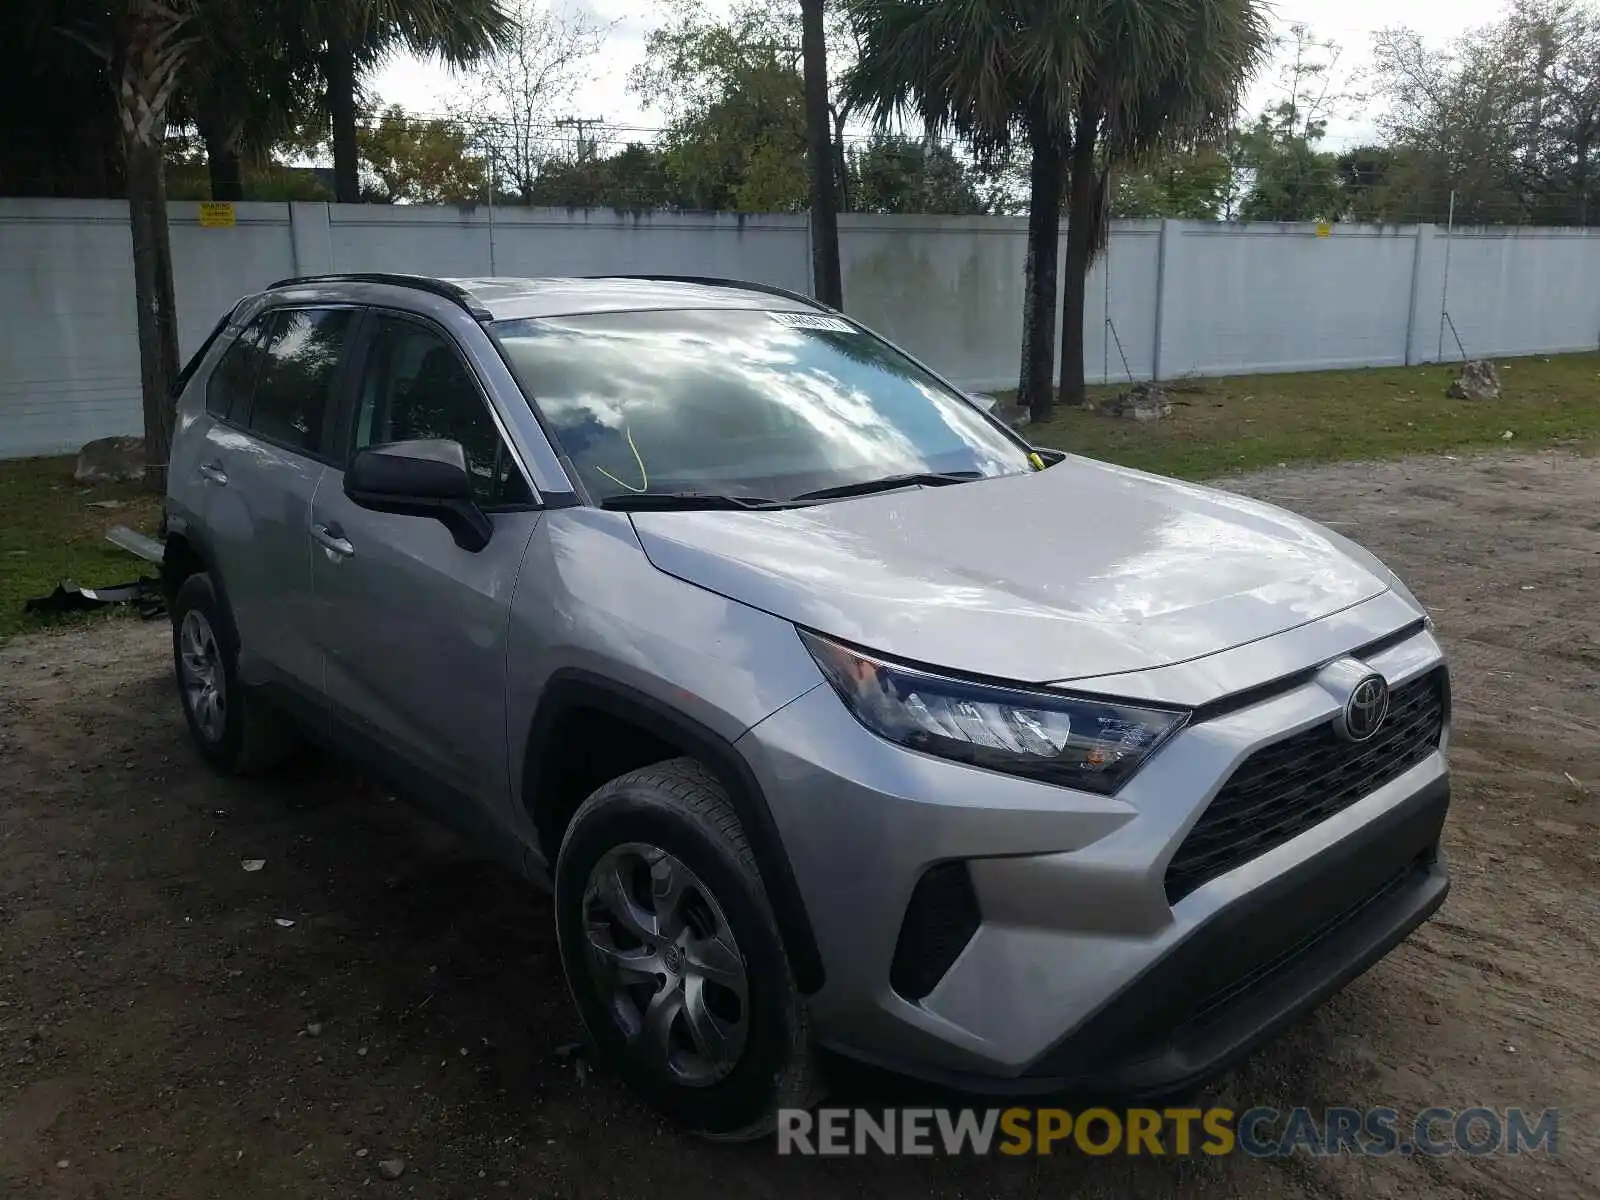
1061 0 1270 403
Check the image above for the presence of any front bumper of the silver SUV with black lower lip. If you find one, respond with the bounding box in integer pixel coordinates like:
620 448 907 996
739 614 1450 1096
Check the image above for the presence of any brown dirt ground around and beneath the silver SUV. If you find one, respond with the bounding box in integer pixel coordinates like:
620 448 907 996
0 454 1600 1200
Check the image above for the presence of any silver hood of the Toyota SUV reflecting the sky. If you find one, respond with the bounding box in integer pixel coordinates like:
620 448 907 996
634 456 1389 683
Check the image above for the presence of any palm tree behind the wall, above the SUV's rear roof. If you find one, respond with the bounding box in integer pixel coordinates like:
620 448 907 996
305 0 515 203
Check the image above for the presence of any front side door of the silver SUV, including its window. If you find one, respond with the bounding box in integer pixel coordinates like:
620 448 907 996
312 310 539 826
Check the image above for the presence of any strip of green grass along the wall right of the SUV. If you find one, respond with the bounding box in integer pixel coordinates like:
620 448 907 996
1005 354 1600 478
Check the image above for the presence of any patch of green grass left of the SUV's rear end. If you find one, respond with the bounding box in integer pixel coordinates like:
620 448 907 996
0 458 162 640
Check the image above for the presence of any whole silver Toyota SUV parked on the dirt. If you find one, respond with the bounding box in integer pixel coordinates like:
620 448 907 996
165 275 1450 1136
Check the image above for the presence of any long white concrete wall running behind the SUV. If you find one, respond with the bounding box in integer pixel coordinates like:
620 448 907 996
0 200 1600 458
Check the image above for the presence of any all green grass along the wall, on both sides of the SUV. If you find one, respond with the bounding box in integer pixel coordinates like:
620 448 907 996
0 354 1600 638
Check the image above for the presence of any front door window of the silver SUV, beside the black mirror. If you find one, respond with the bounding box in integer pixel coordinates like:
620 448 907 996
352 315 533 507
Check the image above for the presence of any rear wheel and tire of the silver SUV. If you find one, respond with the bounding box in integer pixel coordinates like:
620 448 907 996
171 571 294 774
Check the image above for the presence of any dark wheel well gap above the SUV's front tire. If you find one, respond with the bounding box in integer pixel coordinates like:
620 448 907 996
525 706 693 864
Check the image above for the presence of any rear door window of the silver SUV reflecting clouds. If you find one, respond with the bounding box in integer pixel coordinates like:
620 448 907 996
250 309 355 453
